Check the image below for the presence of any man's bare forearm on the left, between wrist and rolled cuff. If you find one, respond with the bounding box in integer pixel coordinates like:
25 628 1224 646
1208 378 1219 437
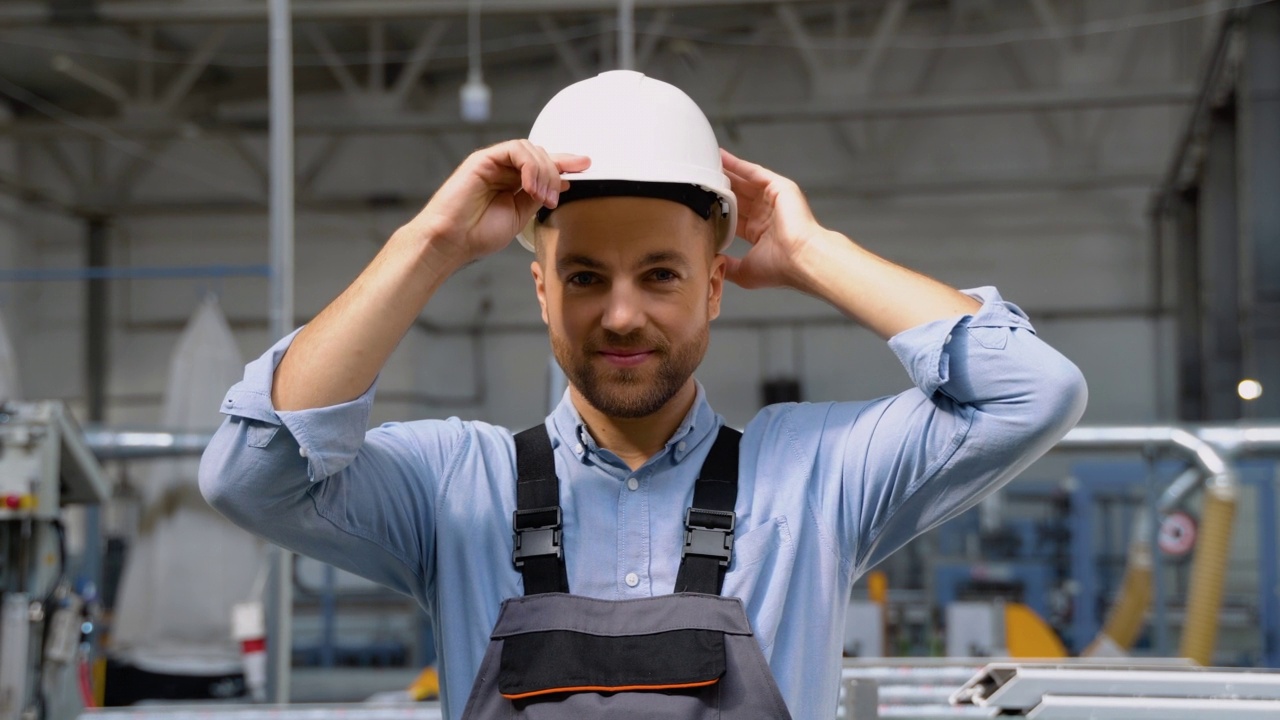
271 223 463 410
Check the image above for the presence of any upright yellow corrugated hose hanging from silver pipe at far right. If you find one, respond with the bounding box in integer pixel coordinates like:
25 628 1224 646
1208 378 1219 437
1178 486 1235 665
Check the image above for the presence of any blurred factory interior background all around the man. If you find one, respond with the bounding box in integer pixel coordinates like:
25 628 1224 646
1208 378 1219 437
0 0 1280 720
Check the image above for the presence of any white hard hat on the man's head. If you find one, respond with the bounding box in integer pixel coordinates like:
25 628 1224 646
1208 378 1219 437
518 70 737 250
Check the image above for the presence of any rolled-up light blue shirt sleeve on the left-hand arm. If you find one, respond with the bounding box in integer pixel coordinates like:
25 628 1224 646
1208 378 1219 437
200 333 462 605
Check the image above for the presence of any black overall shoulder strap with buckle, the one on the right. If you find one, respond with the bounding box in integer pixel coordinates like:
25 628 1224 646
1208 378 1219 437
676 425 742 594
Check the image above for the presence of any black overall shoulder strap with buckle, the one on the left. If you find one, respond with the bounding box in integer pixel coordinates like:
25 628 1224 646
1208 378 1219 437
511 423 568 594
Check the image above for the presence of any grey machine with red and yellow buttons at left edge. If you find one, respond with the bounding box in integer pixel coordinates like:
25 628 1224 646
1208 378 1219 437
0 402 108 720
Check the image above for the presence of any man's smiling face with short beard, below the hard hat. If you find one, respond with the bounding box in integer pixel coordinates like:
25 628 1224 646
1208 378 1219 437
532 197 724 418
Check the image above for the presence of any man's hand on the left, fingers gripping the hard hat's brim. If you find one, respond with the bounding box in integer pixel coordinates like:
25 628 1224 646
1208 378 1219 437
410 140 591 263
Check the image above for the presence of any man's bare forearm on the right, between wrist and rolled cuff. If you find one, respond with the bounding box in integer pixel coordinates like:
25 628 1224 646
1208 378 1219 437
794 231 982 340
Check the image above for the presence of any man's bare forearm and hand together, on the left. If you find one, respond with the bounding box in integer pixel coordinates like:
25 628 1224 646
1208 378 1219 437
271 140 591 410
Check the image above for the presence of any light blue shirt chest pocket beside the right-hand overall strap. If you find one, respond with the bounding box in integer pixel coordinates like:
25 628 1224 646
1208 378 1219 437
723 516 796 652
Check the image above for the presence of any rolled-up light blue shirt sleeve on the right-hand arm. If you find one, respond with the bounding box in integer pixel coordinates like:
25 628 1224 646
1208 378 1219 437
803 287 1088 574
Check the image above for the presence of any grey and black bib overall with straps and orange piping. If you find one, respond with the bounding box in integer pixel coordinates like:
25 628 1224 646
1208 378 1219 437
462 425 791 720
